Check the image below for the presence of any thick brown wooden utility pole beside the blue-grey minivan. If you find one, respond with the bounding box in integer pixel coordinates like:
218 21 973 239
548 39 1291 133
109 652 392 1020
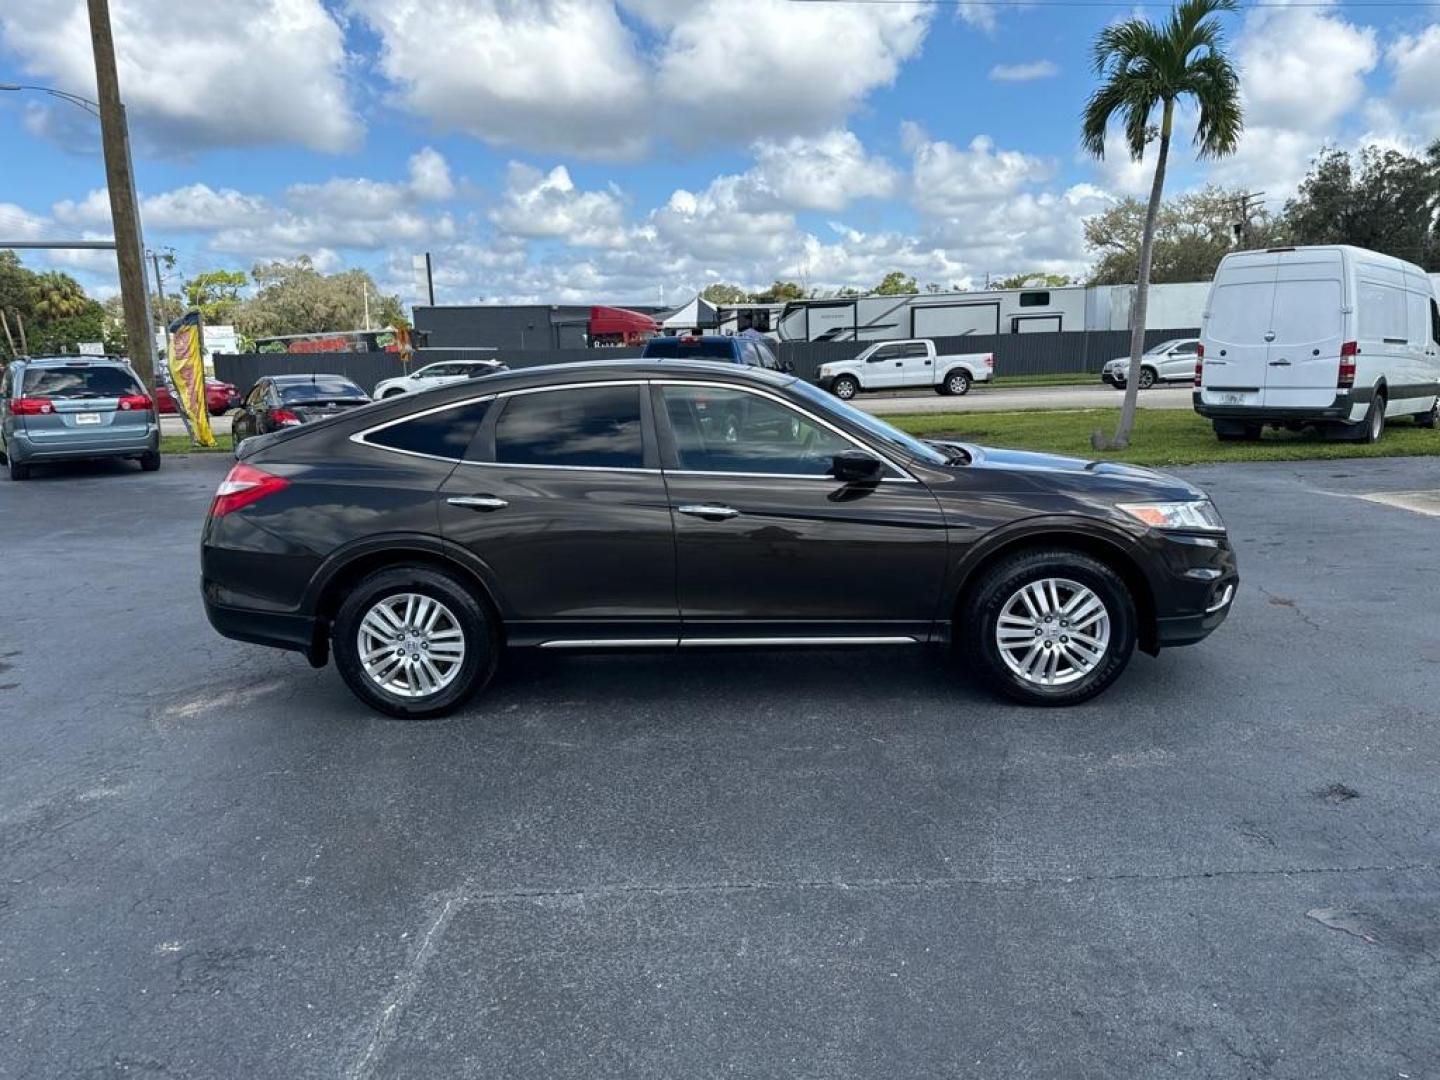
86 0 156 387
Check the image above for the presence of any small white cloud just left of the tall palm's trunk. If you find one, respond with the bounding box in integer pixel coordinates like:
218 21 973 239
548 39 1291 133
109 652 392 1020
903 122 1053 215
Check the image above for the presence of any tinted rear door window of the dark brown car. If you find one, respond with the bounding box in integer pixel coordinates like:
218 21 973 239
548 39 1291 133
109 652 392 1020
495 386 645 468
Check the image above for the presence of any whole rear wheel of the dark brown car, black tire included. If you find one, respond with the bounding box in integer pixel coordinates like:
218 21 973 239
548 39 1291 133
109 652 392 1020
331 566 500 720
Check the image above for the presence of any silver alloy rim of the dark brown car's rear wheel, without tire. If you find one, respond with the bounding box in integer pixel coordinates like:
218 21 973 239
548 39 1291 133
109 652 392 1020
356 592 465 698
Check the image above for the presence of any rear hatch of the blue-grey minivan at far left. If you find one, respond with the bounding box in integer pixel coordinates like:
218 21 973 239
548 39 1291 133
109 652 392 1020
16 361 154 445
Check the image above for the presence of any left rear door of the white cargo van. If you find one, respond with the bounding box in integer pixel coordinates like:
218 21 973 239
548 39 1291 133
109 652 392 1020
1201 252 1279 406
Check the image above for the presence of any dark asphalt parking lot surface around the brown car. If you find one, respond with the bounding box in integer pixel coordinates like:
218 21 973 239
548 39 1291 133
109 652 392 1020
0 456 1440 1079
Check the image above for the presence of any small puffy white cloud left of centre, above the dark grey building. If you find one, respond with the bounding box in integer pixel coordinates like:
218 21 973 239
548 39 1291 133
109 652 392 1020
490 161 625 248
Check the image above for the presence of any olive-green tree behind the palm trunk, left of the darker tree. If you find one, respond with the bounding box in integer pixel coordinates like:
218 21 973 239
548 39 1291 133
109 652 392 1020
1084 187 1284 285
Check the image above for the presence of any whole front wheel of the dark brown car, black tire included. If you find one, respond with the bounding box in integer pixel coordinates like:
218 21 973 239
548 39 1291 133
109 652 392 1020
960 547 1136 706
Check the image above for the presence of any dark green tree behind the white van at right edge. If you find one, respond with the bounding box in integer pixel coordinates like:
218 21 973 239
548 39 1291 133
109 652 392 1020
1284 141 1440 271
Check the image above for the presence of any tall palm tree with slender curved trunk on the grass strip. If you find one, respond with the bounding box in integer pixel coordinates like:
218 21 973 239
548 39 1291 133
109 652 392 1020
1081 0 1244 449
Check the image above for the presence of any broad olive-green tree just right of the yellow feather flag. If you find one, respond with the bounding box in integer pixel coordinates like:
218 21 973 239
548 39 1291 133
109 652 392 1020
235 256 405 338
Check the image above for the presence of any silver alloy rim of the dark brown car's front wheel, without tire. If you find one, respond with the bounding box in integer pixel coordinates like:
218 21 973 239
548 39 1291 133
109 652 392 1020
995 577 1110 687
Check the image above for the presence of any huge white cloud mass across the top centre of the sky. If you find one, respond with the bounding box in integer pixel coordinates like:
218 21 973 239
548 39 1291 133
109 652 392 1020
351 0 930 158
